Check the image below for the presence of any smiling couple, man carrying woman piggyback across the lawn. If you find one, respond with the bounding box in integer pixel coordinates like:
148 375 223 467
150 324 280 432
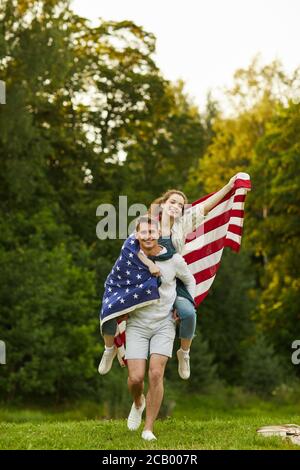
98 176 236 440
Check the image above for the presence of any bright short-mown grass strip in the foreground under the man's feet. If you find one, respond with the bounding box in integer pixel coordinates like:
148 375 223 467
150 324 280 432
0 415 300 450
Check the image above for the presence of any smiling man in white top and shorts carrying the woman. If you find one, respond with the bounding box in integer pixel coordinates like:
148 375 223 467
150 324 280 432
126 216 195 441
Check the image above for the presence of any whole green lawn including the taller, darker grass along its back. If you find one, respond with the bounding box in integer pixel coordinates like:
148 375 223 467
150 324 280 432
0 393 300 450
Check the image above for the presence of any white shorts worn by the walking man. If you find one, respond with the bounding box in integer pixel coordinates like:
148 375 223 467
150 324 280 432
125 318 176 359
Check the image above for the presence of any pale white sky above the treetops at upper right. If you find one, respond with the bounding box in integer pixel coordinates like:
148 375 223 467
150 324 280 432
72 0 300 110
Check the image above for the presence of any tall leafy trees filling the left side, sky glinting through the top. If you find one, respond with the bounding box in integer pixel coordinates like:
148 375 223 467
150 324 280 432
0 0 211 401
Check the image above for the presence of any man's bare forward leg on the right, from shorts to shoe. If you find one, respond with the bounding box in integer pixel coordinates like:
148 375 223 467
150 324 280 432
145 354 168 431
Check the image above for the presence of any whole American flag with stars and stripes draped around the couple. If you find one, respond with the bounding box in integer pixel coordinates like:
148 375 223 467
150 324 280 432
100 173 251 366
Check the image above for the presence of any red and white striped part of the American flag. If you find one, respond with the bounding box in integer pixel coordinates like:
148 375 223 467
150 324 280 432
115 173 251 367
